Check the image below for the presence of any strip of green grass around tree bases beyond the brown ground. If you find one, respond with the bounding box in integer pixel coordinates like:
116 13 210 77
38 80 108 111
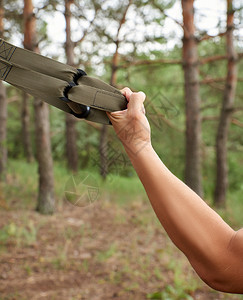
3 160 146 209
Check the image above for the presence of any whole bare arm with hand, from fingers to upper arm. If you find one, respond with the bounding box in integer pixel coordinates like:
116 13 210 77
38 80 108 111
107 88 243 294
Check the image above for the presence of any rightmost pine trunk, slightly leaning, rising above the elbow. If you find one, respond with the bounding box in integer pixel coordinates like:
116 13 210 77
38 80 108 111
214 0 237 207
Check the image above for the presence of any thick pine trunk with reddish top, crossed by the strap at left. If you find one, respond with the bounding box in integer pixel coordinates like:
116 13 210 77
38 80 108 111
24 0 55 214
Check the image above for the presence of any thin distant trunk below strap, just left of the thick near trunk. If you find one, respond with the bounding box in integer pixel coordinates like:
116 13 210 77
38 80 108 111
21 92 33 163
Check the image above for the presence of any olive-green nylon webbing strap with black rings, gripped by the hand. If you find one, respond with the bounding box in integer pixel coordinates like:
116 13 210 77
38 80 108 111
0 39 127 124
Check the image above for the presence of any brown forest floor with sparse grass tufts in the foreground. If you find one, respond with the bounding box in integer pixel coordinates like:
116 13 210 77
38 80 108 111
0 195 243 300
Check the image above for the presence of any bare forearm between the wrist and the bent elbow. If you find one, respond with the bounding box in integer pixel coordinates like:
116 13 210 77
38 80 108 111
127 146 235 277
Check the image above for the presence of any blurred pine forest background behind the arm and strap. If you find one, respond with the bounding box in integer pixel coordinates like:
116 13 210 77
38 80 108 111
0 0 243 300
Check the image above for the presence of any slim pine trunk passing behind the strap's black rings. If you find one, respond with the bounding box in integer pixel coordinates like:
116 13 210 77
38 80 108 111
65 0 78 172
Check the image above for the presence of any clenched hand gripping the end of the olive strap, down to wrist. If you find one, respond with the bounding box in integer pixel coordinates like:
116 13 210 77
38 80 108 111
107 88 151 155
